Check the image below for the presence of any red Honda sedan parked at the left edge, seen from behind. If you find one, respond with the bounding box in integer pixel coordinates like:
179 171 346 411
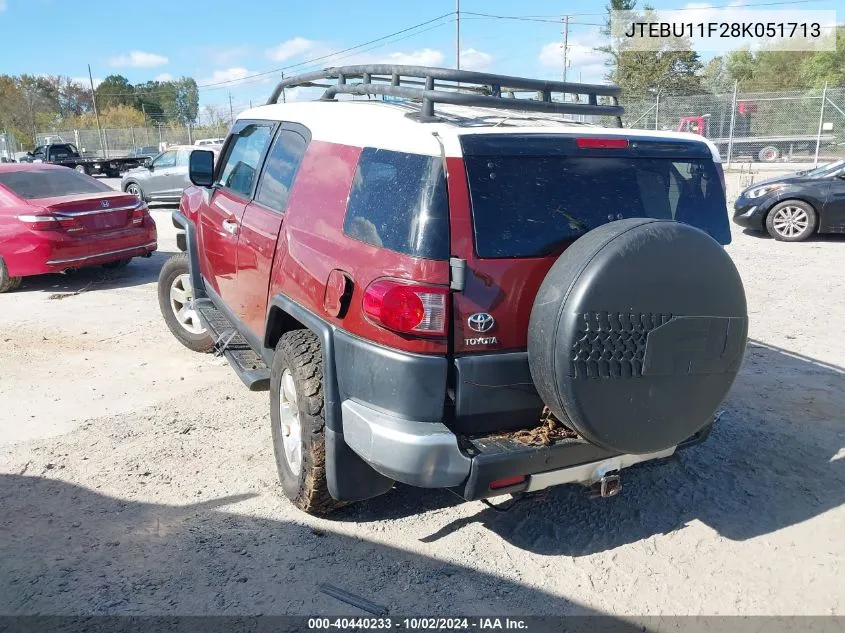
0 164 157 292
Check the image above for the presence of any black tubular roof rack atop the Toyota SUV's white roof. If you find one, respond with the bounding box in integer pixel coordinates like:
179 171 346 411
267 64 624 127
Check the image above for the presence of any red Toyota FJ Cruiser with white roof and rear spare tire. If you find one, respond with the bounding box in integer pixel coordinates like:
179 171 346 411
159 65 748 513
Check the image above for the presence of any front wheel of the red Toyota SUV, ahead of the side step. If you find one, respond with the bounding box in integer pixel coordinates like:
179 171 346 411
158 253 214 353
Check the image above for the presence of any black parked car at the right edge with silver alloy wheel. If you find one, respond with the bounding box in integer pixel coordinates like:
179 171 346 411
733 160 845 242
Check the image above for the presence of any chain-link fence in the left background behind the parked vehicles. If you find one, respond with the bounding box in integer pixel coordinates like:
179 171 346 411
35 125 227 158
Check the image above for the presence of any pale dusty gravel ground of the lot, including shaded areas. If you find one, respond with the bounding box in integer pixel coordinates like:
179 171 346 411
0 184 845 615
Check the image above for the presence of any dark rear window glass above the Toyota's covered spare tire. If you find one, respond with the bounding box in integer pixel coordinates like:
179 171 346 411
464 138 730 258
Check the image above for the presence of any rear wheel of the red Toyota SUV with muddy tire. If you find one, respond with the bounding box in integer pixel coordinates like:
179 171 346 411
270 330 343 515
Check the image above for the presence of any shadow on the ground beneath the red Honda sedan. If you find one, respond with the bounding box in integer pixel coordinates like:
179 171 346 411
15 250 176 299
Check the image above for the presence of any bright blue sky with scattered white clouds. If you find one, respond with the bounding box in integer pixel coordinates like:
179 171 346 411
0 0 843 121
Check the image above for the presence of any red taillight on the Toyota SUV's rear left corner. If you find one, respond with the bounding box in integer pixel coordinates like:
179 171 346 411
364 279 449 336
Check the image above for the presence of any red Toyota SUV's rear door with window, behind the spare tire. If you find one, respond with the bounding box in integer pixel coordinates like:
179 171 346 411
447 133 730 431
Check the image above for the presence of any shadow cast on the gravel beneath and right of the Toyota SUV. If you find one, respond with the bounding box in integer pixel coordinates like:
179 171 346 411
342 341 845 556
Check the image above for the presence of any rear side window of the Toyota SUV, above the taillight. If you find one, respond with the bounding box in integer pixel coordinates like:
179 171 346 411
343 147 449 259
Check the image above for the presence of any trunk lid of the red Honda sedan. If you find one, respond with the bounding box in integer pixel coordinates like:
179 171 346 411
32 192 142 235
